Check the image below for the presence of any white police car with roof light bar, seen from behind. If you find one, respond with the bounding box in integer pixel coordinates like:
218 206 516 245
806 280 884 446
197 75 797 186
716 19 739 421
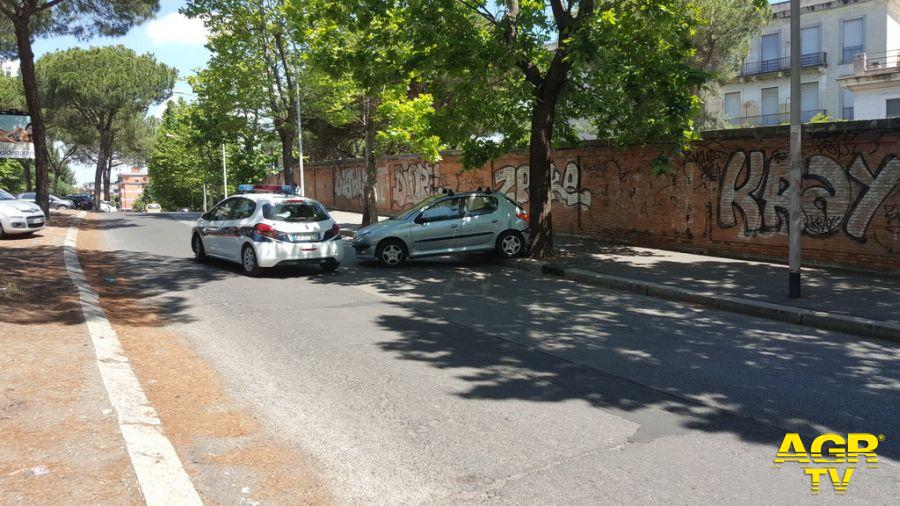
191 185 344 276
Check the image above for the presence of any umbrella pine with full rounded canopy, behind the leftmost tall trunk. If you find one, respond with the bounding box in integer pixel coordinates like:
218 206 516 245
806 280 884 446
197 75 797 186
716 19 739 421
37 46 177 209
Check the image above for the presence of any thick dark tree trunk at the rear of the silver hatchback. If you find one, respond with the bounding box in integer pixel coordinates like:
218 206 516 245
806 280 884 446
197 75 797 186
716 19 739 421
528 91 559 258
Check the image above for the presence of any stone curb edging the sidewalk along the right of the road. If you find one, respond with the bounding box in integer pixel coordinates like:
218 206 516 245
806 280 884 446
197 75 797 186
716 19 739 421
509 258 900 342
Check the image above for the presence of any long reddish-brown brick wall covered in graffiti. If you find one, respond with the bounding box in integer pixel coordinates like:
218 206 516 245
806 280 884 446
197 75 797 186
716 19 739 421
273 118 900 272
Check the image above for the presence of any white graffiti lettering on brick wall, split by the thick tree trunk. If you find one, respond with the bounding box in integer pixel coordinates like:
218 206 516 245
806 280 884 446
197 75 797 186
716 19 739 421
494 162 591 209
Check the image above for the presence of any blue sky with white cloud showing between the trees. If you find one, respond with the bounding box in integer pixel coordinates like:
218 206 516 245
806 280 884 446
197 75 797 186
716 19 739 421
19 0 209 184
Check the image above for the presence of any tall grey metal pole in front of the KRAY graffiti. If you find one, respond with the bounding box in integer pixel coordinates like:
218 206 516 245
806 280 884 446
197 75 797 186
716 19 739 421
788 0 803 299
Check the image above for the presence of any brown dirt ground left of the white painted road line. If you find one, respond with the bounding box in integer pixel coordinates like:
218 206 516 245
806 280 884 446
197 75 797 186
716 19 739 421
0 214 143 504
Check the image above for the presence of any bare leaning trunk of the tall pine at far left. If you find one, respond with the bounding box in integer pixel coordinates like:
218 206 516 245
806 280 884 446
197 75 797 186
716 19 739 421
14 18 50 216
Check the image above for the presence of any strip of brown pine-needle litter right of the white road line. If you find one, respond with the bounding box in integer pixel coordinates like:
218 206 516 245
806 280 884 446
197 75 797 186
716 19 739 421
78 216 331 504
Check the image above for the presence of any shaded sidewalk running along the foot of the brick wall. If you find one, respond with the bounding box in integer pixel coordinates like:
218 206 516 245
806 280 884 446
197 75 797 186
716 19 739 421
332 211 900 341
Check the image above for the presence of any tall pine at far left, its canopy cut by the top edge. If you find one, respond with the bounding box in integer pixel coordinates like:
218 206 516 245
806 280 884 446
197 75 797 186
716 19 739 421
0 0 159 213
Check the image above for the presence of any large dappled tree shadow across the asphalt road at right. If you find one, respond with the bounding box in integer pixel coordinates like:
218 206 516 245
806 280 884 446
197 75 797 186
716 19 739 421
314 255 900 458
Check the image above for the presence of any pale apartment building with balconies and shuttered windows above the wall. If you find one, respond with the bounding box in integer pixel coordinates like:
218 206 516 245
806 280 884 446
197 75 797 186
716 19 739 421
706 0 900 126
